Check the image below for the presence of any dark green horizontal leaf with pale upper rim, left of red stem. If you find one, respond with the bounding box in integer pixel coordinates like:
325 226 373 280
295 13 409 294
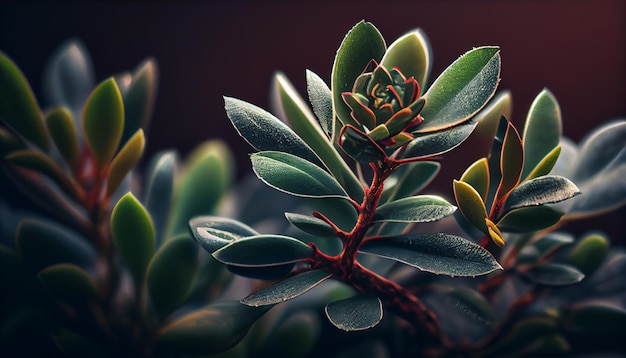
213 235 313 267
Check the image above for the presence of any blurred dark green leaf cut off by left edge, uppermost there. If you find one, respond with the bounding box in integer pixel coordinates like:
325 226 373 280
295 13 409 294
0 52 50 151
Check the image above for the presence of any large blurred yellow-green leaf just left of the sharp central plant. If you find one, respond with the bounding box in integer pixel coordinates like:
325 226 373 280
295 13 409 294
166 140 234 238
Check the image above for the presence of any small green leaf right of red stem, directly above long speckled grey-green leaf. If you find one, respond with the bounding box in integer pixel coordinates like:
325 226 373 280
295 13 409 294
372 195 456 223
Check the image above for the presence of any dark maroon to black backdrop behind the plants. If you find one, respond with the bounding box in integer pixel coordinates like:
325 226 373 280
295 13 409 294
0 0 626 241
